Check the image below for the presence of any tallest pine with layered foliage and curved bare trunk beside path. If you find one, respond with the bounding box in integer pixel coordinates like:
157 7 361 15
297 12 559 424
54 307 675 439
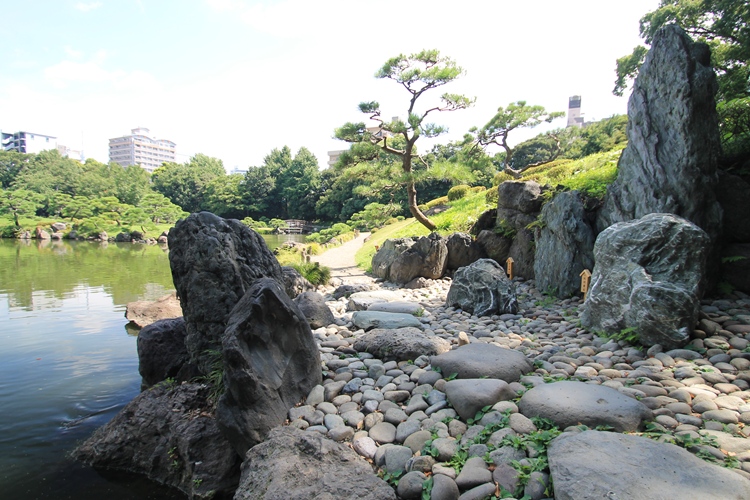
335 50 474 230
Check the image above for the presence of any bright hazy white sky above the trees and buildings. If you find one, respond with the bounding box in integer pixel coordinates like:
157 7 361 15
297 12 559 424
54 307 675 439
0 0 659 171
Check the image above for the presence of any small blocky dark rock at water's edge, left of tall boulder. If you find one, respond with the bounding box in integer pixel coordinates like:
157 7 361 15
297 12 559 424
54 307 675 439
138 318 195 387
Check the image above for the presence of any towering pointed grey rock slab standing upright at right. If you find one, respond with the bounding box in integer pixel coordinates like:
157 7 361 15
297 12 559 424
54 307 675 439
597 25 722 242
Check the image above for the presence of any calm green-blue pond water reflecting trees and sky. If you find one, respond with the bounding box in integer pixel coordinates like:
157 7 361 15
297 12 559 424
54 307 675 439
0 235 306 500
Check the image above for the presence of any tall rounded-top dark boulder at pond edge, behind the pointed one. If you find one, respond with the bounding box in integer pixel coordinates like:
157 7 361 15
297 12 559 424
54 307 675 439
169 212 282 373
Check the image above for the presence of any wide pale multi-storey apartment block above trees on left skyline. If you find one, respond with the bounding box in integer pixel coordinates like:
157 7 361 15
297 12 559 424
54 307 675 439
109 127 176 172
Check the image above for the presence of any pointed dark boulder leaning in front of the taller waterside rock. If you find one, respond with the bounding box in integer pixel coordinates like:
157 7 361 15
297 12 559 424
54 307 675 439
216 278 322 455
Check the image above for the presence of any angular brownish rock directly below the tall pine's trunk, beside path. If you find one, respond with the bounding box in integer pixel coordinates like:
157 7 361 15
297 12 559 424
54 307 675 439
388 233 448 283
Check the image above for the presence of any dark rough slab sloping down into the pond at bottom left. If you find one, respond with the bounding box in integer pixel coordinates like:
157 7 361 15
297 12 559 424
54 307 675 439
73 384 241 498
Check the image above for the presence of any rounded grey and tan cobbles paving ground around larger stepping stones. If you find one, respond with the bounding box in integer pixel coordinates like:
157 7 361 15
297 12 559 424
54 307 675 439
288 278 750 500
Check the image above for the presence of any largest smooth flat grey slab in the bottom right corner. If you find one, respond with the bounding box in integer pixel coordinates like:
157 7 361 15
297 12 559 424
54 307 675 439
547 430 750 500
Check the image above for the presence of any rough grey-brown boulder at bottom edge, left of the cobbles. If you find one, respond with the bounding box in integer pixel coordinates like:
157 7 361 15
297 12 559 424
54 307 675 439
234 427 396 500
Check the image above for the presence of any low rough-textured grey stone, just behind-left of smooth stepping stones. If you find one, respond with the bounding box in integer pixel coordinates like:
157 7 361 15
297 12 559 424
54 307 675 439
354 327 451 361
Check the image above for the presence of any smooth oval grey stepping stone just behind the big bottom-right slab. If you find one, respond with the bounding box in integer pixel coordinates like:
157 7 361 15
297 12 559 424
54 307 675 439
518 381 653 432
